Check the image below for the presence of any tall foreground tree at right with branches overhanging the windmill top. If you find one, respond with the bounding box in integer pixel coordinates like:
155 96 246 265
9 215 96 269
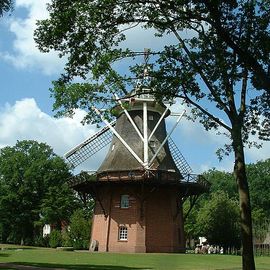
35 0 270 269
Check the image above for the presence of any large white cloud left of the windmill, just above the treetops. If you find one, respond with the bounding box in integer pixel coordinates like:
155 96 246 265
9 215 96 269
0 98 102 170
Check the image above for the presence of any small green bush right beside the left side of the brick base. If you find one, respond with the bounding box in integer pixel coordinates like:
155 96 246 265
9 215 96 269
68 210 91 249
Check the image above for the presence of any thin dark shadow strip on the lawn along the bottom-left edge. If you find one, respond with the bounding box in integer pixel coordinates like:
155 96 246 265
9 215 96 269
10 262 152 270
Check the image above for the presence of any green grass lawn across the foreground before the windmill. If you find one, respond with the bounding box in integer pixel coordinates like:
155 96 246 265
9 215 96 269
0 245 270 270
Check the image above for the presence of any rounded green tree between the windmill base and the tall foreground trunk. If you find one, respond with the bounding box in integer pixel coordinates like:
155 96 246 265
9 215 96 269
196 191 240 248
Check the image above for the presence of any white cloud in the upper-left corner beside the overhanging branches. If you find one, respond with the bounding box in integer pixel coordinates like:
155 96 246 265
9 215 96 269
0 0 65 75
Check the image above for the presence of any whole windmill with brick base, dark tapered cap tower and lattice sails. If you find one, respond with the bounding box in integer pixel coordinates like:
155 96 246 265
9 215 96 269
65 53 208 252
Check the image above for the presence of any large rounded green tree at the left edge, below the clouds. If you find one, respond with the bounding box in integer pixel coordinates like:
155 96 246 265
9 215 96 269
0 141 75 244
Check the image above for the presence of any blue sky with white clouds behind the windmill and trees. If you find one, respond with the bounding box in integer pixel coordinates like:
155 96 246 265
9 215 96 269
0 0 270 172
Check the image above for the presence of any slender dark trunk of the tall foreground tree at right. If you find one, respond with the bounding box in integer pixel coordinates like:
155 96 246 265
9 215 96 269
232 125 255 270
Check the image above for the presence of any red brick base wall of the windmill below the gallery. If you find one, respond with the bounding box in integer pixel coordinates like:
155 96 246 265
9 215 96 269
92 185 185 252
